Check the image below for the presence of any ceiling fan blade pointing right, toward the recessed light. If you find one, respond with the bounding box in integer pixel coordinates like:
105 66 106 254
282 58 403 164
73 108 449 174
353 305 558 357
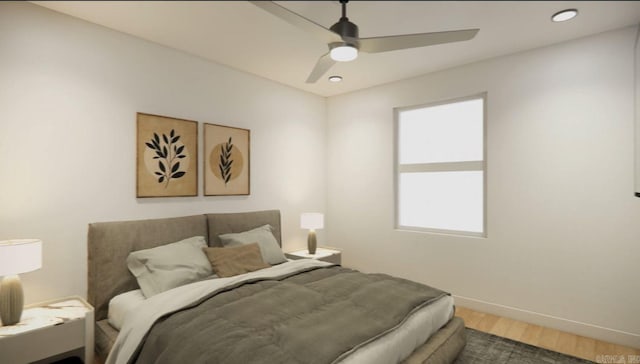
359 29 480 53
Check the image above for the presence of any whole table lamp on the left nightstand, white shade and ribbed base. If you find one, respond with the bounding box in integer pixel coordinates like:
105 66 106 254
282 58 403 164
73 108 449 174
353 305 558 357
0 239 42 326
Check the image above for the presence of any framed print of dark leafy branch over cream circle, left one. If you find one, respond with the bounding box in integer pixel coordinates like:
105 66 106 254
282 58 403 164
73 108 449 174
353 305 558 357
136 113 198 197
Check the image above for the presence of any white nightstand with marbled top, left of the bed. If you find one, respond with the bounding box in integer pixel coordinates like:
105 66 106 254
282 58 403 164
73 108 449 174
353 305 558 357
0 297 94 364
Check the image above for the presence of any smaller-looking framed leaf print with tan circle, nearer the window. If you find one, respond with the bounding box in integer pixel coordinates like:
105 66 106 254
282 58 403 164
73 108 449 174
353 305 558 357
203 124 250 196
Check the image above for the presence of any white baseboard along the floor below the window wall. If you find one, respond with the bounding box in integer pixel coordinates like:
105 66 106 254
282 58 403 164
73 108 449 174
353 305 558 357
453 295 640 348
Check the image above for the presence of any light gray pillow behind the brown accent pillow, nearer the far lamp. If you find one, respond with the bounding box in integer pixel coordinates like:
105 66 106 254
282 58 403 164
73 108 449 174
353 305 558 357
218 225 287 265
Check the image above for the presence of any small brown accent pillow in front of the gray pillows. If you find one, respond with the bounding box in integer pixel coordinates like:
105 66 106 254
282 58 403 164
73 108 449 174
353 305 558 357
202 243 270 277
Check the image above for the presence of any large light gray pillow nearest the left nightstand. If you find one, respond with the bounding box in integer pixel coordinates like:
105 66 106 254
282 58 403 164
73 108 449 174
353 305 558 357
127 236 213 298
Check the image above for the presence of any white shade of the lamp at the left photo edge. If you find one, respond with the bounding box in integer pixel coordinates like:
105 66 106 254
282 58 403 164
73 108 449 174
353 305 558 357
0 239 42 276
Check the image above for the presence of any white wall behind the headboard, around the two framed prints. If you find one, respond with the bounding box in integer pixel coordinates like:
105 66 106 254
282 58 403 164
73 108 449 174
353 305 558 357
0 2 326 302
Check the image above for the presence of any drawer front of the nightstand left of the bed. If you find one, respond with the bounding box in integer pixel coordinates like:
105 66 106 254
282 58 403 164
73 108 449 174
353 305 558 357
0 320 85 364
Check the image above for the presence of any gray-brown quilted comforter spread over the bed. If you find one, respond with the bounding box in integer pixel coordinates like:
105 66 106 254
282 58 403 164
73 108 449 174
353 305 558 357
130 266 447 364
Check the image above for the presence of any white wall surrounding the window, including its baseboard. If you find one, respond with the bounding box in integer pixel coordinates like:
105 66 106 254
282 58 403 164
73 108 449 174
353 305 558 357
326 28 640 347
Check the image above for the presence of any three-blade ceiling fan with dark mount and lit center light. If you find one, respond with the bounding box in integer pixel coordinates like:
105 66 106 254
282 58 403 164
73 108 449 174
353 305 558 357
251 0 480 83
